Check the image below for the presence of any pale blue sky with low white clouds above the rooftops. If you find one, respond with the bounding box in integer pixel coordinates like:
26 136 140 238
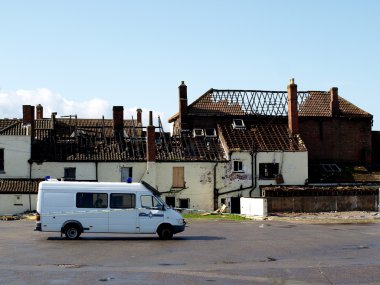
0 0 380 131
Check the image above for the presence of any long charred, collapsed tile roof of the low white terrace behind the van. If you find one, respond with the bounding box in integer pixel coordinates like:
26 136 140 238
0 117 225 162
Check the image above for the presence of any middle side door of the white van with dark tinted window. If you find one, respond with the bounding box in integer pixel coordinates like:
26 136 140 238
108 193 139 233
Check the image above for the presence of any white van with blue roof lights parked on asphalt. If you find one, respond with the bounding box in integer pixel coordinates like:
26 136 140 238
36 181 186 239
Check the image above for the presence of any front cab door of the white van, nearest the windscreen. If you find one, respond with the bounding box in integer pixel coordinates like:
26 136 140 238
138 194 164 233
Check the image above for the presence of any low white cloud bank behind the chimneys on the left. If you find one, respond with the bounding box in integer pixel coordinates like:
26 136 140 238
0 88 171 132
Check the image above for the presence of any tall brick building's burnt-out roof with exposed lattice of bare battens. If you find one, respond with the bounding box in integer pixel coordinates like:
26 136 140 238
169 89 372 120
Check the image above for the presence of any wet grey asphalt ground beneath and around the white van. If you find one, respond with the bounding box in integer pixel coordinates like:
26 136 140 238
0 216 380 285
